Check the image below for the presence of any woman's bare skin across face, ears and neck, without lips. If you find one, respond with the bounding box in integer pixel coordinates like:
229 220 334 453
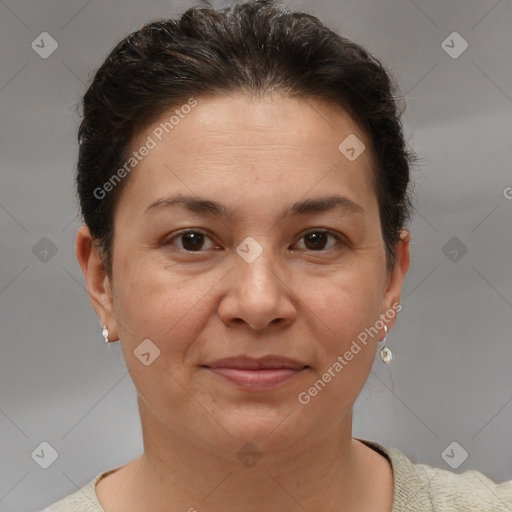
76 94 409 512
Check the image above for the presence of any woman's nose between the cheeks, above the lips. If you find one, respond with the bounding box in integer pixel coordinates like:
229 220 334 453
219 241 297 330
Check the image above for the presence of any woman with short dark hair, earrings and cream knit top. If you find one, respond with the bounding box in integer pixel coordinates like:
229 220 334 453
46 0 512 512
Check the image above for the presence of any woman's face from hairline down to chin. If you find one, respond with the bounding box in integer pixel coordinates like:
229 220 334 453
79 95 408 460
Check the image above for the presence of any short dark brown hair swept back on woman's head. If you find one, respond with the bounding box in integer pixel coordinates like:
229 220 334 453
76 0 417 275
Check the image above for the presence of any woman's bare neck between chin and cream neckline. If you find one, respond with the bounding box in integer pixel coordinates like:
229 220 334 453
109 404 392 512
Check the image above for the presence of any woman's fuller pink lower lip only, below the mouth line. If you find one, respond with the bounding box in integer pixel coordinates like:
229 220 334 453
206 367 306 391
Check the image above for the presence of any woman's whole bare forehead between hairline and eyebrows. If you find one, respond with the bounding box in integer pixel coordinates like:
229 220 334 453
119 94 380 224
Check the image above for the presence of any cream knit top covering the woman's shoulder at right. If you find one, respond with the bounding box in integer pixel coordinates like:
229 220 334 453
360 440 512 512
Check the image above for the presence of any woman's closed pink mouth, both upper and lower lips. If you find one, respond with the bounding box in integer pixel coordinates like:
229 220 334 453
201 356 310 391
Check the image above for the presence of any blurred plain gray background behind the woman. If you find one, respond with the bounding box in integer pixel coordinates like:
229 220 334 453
0 0 512 511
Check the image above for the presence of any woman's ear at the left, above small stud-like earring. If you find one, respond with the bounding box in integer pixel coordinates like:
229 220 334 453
75 224 119 341
